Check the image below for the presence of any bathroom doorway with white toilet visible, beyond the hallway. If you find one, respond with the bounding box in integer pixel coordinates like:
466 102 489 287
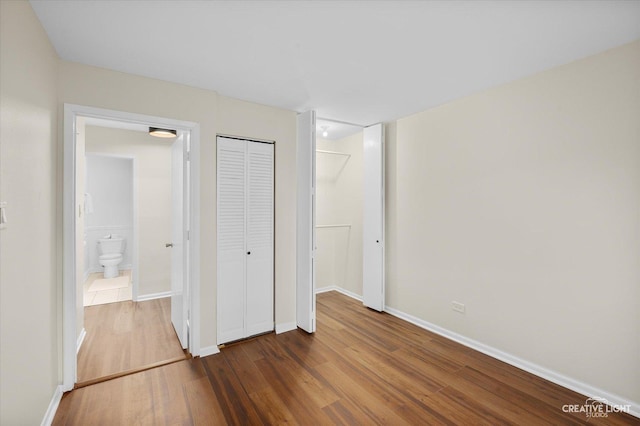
79 153 134 306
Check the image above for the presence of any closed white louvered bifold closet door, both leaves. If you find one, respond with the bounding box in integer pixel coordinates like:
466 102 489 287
217 137 274 344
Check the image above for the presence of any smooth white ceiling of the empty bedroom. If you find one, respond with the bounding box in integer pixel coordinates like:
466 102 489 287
31 0 640 129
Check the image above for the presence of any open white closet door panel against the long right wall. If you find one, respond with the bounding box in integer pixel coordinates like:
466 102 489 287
362 124 385 311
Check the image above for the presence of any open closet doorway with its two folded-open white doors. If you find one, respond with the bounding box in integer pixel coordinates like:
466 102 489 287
297 111 385 333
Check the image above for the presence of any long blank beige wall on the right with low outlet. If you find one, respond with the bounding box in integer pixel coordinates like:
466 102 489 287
387 42 640 402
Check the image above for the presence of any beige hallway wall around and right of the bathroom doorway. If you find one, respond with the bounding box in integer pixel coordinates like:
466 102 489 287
86 126 174 296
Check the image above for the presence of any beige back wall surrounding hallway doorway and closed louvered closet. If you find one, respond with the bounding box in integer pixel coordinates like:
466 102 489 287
59 61 296 348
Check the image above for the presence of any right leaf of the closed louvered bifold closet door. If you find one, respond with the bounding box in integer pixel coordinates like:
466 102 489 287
246 142 274 336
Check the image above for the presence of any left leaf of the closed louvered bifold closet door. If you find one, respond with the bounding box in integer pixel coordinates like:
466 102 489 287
217 138 247 344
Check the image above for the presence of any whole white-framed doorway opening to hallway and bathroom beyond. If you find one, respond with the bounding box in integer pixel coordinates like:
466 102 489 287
63 104 199 390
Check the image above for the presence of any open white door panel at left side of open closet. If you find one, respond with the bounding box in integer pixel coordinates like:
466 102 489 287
296 111 316 333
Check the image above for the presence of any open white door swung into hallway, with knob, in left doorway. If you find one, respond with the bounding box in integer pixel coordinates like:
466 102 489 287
167 132 189 349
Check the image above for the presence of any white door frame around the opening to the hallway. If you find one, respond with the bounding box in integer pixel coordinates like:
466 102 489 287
62 103 200 392
